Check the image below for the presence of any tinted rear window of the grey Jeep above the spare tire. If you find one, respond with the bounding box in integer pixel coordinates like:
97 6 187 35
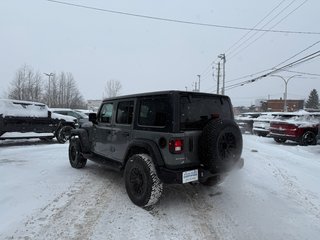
180 94 233 130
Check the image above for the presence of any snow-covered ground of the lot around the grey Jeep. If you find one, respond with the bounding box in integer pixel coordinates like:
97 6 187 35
0 135 320 240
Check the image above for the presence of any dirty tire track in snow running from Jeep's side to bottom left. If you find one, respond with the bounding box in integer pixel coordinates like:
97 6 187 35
7 169 120 240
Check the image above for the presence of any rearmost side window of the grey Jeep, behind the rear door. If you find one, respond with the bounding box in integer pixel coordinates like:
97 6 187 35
138 98 170 127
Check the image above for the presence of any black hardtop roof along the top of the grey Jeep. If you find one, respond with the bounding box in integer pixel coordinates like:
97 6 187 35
103 90 229 102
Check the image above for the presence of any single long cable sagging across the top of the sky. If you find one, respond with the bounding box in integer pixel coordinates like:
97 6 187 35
46 0 320 35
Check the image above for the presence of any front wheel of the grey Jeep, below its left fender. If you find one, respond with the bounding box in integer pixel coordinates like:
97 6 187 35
69 138 87 168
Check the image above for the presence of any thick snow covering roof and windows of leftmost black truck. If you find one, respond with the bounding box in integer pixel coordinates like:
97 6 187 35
0 99 49 117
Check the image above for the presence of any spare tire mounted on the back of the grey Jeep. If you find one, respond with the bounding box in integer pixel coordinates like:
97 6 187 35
198 119 242 172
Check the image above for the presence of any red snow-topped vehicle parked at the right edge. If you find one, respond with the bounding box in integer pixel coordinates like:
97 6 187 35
270 113 320 145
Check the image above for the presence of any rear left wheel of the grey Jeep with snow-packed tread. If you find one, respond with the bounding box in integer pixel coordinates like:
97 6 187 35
124 154 163 207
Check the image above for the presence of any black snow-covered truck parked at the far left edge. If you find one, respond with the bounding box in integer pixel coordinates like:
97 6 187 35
0 99 78 143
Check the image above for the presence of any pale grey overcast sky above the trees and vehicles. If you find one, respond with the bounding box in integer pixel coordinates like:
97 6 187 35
0 0 320 106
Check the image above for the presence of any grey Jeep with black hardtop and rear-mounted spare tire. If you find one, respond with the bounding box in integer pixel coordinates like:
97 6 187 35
69 91 243 206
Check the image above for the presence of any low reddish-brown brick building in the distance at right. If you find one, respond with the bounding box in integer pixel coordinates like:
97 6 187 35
262 99 304 112
